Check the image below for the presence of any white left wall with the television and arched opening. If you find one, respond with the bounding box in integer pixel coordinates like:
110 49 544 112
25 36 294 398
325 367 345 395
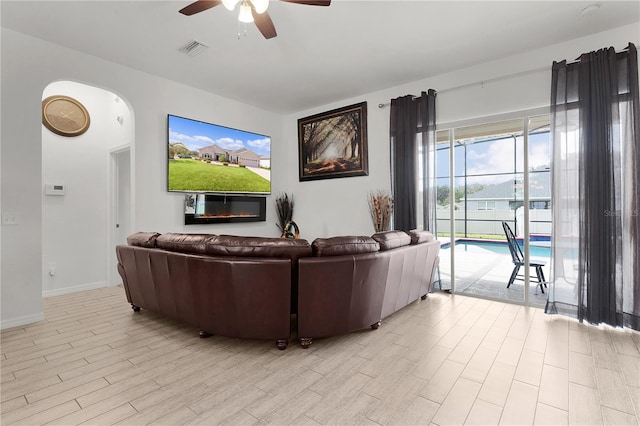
0 28 288 328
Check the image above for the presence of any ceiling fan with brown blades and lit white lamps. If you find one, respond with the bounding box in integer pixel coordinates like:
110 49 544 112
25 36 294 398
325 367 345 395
180 0 331 39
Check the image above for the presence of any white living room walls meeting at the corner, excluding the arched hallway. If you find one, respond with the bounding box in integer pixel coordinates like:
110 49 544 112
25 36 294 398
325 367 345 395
0 25 640 328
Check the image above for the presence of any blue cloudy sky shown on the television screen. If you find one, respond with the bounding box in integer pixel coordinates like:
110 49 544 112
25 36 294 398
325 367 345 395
168 115 271 156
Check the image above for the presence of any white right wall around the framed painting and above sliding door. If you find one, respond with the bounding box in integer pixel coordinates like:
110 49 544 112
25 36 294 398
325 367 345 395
284 24 640 239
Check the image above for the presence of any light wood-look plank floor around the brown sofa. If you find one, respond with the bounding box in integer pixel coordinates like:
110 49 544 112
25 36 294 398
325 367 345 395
0 287 640 425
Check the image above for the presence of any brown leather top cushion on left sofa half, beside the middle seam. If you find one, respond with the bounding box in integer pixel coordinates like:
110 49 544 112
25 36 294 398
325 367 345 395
206 235 311 260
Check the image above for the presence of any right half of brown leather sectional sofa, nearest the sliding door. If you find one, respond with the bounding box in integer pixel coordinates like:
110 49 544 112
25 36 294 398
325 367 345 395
298 231 440 348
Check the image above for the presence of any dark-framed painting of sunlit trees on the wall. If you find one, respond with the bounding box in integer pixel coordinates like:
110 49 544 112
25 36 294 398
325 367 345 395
298 102 369 181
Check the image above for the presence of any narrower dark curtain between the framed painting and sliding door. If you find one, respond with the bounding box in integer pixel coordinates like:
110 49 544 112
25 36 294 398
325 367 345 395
390 89 436 233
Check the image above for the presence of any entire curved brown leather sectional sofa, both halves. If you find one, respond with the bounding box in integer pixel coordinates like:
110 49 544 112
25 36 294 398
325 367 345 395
116 231 440 349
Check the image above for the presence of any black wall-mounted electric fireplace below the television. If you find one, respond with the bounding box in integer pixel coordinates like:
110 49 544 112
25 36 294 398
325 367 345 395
184 194 267 225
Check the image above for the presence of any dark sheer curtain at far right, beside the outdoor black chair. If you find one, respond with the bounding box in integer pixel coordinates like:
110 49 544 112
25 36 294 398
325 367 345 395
546 43 640 330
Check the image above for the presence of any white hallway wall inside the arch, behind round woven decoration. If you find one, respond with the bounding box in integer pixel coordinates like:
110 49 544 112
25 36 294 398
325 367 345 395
42 81 133 297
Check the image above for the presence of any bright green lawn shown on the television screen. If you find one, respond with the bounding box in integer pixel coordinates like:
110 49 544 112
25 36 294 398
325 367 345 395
169 159 271 193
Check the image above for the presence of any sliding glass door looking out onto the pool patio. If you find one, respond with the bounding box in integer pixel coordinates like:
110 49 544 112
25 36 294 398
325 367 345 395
436 115 551 306
